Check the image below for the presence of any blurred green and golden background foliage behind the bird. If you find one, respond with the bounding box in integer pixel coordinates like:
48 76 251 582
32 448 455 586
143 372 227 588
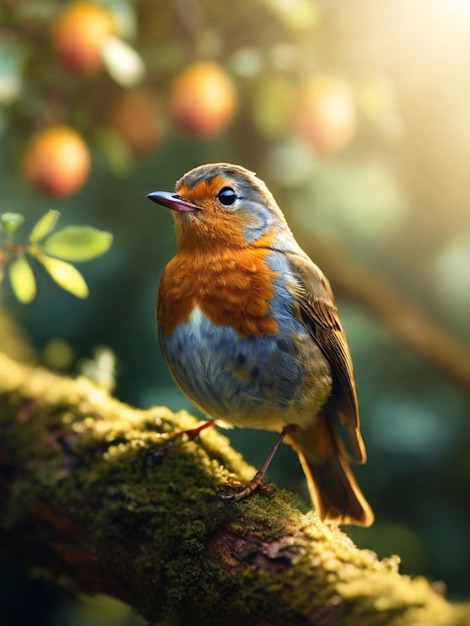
0 0 470 626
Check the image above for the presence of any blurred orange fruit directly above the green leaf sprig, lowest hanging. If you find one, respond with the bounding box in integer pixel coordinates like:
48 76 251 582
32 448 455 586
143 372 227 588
21 125 90 197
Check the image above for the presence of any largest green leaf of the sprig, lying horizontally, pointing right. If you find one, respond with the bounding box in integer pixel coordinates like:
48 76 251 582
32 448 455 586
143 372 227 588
43 226 113 261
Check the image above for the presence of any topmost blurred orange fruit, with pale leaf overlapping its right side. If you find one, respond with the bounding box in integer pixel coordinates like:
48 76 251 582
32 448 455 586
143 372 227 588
52 2 116 74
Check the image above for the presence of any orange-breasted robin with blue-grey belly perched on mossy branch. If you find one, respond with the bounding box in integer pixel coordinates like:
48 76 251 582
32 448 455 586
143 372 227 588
147 163 374 526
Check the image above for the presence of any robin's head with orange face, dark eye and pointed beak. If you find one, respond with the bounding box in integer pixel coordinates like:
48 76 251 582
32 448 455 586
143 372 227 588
148 163 293 249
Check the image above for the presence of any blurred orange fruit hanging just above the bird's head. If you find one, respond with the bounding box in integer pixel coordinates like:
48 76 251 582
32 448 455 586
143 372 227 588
169 62 238 137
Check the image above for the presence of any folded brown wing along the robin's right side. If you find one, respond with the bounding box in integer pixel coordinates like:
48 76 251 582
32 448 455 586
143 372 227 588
287 253 366 463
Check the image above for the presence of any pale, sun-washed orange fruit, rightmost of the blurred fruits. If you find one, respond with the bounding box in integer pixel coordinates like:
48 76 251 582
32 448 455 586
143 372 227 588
292 77 357 154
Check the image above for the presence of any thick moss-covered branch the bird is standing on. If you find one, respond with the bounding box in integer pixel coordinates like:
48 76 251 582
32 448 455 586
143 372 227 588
0 355 470 626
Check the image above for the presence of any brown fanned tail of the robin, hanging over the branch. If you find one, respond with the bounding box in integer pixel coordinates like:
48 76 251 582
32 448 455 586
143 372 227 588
288 413 374 526
